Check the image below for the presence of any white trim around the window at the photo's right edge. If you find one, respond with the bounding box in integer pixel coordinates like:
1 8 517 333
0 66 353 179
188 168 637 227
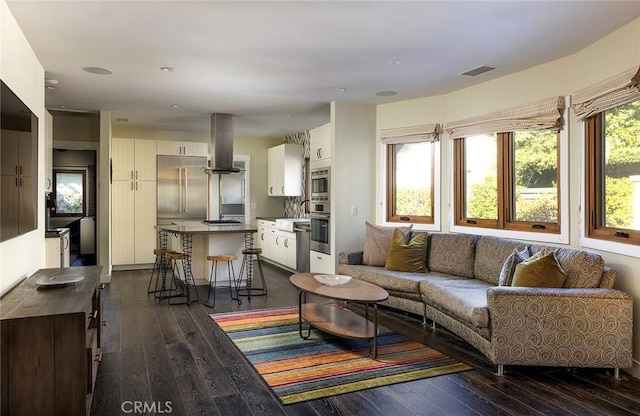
578 120 640 258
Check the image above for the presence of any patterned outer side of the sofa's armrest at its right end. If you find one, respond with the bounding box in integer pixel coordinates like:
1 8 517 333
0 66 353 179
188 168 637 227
487 287 633 368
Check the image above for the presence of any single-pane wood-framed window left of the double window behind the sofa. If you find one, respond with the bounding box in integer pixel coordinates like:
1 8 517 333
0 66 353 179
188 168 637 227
387 142 436 224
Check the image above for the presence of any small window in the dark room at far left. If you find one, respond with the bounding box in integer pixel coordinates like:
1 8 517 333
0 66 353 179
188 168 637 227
52 169 87 217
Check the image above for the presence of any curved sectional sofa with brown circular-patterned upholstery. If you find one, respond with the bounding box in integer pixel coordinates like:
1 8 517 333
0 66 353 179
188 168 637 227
337 232 633 378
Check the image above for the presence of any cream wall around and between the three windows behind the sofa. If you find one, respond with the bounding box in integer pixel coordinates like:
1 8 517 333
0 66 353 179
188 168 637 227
376 19 640 378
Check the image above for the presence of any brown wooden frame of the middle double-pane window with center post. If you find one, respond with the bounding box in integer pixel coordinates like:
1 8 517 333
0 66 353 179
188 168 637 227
452 132 565 236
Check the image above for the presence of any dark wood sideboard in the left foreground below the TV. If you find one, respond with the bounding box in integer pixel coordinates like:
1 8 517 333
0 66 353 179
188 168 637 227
0 266 102 416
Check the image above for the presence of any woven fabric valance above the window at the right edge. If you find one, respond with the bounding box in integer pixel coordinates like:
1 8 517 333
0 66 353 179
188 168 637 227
571 67 640 119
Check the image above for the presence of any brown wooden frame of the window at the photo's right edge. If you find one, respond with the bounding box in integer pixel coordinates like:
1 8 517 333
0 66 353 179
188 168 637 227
584 111 640 246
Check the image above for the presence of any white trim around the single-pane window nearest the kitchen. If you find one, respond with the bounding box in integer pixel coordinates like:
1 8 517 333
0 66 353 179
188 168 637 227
378 141 442 231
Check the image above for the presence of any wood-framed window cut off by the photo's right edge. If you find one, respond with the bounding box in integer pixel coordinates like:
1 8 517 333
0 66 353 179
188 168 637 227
585 100 640 245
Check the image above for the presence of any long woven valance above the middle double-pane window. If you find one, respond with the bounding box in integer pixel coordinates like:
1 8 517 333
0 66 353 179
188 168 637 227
445 96 564 139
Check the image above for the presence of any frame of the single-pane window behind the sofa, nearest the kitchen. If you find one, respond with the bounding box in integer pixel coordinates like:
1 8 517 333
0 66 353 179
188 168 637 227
381 140 440 230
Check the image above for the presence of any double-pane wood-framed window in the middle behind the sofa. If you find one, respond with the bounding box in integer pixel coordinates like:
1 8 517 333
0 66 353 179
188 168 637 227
454 130 560 233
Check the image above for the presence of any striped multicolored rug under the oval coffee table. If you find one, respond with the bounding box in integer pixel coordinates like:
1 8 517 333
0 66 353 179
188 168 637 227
211 307 470 404
